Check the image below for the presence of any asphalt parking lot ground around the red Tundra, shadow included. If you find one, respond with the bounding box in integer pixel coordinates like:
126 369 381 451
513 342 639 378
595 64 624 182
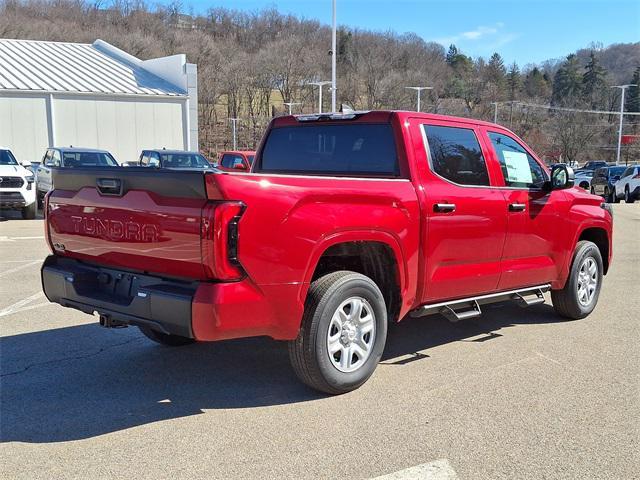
0 204 640 480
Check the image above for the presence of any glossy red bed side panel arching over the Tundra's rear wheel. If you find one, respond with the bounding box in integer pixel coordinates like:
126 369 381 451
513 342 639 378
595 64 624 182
207 173 420 321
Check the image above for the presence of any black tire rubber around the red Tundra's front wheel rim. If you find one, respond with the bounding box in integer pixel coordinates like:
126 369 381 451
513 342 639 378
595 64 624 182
551 240 604 320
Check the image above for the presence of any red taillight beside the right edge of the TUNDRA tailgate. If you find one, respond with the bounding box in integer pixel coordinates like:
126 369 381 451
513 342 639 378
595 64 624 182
201 202 245 281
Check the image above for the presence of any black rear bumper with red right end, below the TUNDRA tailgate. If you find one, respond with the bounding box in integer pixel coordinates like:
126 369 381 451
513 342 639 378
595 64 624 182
42 255 303 341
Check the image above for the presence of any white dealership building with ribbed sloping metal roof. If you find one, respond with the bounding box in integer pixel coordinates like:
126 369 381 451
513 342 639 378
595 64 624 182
0 39 198 162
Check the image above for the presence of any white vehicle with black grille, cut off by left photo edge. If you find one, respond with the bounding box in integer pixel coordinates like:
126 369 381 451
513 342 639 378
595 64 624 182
0 148 38 219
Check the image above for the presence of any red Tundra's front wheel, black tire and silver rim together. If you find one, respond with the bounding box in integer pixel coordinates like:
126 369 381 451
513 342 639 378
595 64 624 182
551 240 603 320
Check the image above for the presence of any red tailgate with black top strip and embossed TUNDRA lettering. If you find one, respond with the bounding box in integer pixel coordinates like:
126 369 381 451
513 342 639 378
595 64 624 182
47 167 207 279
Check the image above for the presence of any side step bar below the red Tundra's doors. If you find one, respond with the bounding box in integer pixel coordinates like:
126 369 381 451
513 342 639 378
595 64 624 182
409 284 551 322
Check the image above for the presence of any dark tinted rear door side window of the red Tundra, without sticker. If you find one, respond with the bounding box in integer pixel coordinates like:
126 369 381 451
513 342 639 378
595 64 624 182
422 125 490 185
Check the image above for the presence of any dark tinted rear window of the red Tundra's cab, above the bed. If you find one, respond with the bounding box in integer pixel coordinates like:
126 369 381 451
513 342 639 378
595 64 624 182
256 124 400 177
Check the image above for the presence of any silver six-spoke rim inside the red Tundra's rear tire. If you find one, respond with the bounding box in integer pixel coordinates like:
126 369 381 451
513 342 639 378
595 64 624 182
327 297 376 373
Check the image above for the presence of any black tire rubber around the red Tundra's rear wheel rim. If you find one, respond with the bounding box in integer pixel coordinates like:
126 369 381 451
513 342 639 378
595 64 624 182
289 271 387 395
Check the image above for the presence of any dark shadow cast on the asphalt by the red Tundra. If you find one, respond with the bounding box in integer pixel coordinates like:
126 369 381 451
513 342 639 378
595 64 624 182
0 304 563 443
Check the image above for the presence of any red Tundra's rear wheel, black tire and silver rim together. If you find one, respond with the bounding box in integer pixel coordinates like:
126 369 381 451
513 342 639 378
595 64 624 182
289 271 387 395
